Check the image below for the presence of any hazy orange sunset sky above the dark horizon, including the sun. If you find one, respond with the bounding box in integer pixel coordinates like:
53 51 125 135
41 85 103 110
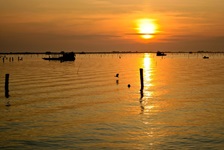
0 0 224 52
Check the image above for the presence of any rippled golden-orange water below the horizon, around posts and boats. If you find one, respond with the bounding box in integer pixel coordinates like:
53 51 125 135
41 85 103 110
0 54 224 149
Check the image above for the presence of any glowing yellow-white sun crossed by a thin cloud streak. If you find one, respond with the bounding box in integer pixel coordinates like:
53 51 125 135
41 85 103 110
137 19 157 39
